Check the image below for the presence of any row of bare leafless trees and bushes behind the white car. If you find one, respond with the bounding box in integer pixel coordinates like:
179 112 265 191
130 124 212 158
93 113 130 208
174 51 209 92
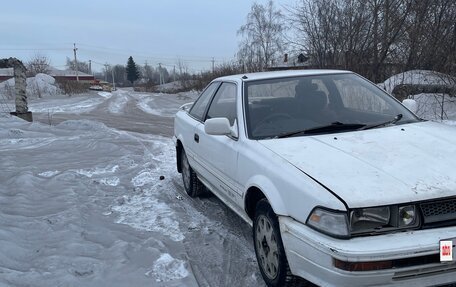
238 0 456 82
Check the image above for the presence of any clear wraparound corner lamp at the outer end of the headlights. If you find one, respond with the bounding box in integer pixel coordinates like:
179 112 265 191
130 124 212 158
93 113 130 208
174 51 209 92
307 207 348 237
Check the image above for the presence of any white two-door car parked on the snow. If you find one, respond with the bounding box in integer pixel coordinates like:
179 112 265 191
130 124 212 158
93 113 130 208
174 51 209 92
174 70 456 286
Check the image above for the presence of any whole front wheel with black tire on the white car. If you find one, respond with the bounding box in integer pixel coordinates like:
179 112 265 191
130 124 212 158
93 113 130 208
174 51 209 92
253 199 305 287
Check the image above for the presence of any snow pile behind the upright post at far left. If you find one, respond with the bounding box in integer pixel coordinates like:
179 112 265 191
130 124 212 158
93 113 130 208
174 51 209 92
0 74 61 99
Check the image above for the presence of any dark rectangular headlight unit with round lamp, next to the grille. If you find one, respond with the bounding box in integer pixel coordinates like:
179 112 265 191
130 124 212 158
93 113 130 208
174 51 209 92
350 205 420 235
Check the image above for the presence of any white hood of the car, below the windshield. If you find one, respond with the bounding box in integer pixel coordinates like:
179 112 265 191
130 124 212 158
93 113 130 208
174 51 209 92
260 122 456 208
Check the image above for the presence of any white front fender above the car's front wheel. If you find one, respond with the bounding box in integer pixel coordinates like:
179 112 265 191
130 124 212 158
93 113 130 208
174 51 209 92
239 140 346 223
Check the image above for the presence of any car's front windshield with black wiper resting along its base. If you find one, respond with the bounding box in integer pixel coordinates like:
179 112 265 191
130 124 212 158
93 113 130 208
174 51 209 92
244 73 419 139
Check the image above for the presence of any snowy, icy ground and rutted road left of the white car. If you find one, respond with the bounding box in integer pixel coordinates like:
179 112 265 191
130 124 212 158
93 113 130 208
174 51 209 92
0 90 264 287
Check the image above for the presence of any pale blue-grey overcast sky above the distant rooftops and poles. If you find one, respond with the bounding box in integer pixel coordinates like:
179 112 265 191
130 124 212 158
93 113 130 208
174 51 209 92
0 0 295 72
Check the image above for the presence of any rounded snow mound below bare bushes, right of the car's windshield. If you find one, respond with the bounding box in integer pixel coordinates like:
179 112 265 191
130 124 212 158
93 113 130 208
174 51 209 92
379 70 456 93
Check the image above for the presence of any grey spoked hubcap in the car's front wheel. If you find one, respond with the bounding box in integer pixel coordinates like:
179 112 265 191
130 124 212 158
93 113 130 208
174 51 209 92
255 215 279 280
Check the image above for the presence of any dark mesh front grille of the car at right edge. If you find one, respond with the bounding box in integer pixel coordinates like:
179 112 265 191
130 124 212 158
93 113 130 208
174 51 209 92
420 198 456 224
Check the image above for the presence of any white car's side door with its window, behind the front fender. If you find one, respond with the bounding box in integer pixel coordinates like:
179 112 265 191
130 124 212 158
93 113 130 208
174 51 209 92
191 82 242 206
